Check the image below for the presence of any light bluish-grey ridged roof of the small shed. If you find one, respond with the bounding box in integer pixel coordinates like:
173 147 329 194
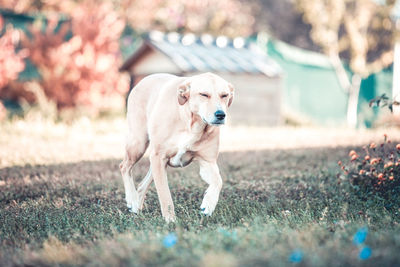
121 31 282 77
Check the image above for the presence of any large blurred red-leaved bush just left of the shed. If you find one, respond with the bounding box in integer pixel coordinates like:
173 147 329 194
23 1 128 113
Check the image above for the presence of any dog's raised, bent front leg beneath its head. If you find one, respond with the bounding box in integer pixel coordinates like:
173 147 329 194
199 160 222 216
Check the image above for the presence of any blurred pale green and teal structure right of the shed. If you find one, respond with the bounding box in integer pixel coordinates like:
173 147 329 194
263 35 393 127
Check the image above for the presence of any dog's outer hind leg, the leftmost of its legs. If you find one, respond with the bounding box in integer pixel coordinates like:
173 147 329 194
119 132 149 213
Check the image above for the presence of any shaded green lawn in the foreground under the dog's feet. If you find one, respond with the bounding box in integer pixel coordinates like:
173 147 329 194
0 147 400 266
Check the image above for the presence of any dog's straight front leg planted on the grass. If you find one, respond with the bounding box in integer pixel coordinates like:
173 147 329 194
150 152 175 222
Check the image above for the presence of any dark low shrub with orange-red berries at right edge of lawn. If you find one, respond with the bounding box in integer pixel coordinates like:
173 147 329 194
338 134 400 199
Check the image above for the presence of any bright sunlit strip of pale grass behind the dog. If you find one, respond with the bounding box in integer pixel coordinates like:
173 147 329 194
0 117 400 167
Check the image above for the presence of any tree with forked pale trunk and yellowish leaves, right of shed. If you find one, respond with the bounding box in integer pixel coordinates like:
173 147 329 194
295 0 395 127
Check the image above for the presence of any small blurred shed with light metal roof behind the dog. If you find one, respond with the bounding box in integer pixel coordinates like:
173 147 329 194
120 32 283 126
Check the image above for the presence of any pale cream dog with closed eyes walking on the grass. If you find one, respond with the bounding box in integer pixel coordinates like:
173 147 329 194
119 73 234 222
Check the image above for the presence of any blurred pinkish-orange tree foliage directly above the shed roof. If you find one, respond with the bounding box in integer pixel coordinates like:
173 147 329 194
114 0 255 36
